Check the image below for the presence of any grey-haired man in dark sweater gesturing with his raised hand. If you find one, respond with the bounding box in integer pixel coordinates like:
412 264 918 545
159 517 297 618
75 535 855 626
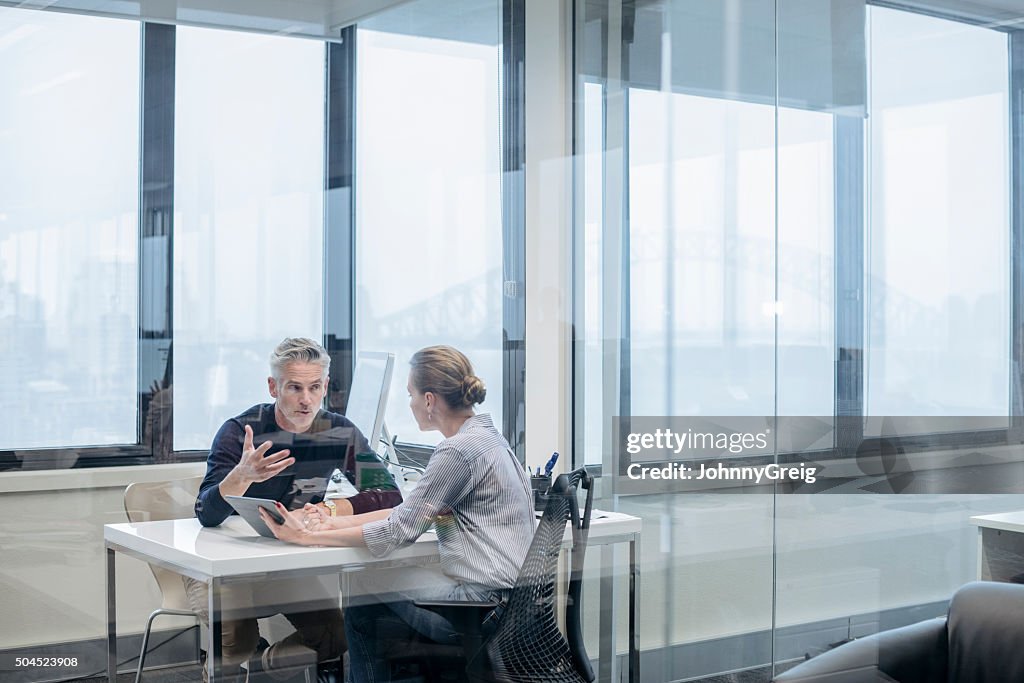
190 338 401 680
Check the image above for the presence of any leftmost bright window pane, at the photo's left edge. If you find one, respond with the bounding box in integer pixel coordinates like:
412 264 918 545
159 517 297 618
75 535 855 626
0 8 139 449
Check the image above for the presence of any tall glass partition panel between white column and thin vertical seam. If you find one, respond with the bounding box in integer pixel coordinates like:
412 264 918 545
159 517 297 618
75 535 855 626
573 2 778 681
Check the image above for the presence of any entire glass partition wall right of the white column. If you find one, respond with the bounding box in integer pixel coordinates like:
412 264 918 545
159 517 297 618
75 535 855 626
573 0 1024 681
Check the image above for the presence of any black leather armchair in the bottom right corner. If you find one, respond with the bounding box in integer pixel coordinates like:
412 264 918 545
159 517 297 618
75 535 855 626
773 582 1024 683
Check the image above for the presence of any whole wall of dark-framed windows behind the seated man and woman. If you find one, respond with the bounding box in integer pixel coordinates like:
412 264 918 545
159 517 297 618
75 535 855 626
0 0 512 683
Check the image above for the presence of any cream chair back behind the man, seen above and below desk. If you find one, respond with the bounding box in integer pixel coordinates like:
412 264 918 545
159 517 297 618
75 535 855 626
125 477 203 609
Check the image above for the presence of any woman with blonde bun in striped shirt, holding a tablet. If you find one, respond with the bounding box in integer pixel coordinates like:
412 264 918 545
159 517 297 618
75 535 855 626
261 346 535 683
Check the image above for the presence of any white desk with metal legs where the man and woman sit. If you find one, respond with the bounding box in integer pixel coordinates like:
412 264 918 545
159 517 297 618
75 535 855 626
103 510 641 683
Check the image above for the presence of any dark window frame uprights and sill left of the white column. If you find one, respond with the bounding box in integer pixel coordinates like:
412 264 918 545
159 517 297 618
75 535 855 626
0 0 525 472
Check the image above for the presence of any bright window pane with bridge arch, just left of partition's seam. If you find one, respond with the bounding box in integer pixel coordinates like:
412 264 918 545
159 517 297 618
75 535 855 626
629 88 775 416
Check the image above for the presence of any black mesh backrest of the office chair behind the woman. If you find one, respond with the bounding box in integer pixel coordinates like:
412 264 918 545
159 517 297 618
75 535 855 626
483 468 594 683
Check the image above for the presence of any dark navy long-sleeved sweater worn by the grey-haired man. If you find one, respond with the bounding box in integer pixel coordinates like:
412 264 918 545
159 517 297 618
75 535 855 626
196 403 401 526
